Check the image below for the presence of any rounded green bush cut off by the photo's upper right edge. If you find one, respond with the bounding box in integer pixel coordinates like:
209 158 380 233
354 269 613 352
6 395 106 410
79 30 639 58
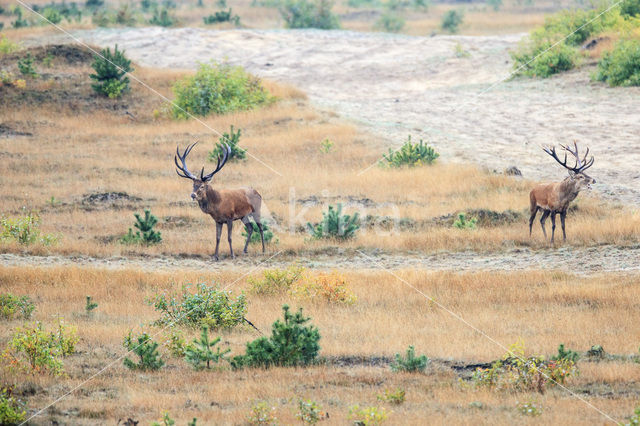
595 40 640 86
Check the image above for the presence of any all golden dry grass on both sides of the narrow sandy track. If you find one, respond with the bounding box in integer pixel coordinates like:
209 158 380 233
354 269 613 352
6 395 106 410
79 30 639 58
0 20 640 424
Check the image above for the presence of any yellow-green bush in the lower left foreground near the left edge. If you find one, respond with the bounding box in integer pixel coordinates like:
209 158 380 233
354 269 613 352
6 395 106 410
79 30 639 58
3 320 78 375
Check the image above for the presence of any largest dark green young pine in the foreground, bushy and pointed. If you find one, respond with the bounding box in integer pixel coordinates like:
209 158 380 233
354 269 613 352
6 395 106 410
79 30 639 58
231 305 320 368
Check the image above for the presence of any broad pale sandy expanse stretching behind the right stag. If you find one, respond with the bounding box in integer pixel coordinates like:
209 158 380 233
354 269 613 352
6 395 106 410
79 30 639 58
65 28 640 204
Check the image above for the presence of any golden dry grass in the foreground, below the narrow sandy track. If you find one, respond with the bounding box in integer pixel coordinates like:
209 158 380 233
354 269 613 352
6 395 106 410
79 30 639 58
0 267 640 424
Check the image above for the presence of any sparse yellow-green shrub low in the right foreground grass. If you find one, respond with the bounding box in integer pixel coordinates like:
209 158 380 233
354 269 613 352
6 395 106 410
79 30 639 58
472 343 578 393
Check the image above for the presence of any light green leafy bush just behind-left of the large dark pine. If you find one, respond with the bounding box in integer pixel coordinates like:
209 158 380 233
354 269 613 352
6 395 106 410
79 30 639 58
151 283 247 330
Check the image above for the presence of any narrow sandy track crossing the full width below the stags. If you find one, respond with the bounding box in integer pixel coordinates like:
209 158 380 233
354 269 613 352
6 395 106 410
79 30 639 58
0 246 640 275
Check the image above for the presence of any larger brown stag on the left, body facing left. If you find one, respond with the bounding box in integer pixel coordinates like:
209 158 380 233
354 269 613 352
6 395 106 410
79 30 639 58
173 142 264 260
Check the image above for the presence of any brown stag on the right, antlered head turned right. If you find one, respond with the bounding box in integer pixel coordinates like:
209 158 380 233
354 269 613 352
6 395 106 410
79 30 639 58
529 142 596 243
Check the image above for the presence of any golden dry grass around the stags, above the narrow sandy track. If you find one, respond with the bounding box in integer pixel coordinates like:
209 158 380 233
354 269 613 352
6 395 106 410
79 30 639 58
0 45 640 256
